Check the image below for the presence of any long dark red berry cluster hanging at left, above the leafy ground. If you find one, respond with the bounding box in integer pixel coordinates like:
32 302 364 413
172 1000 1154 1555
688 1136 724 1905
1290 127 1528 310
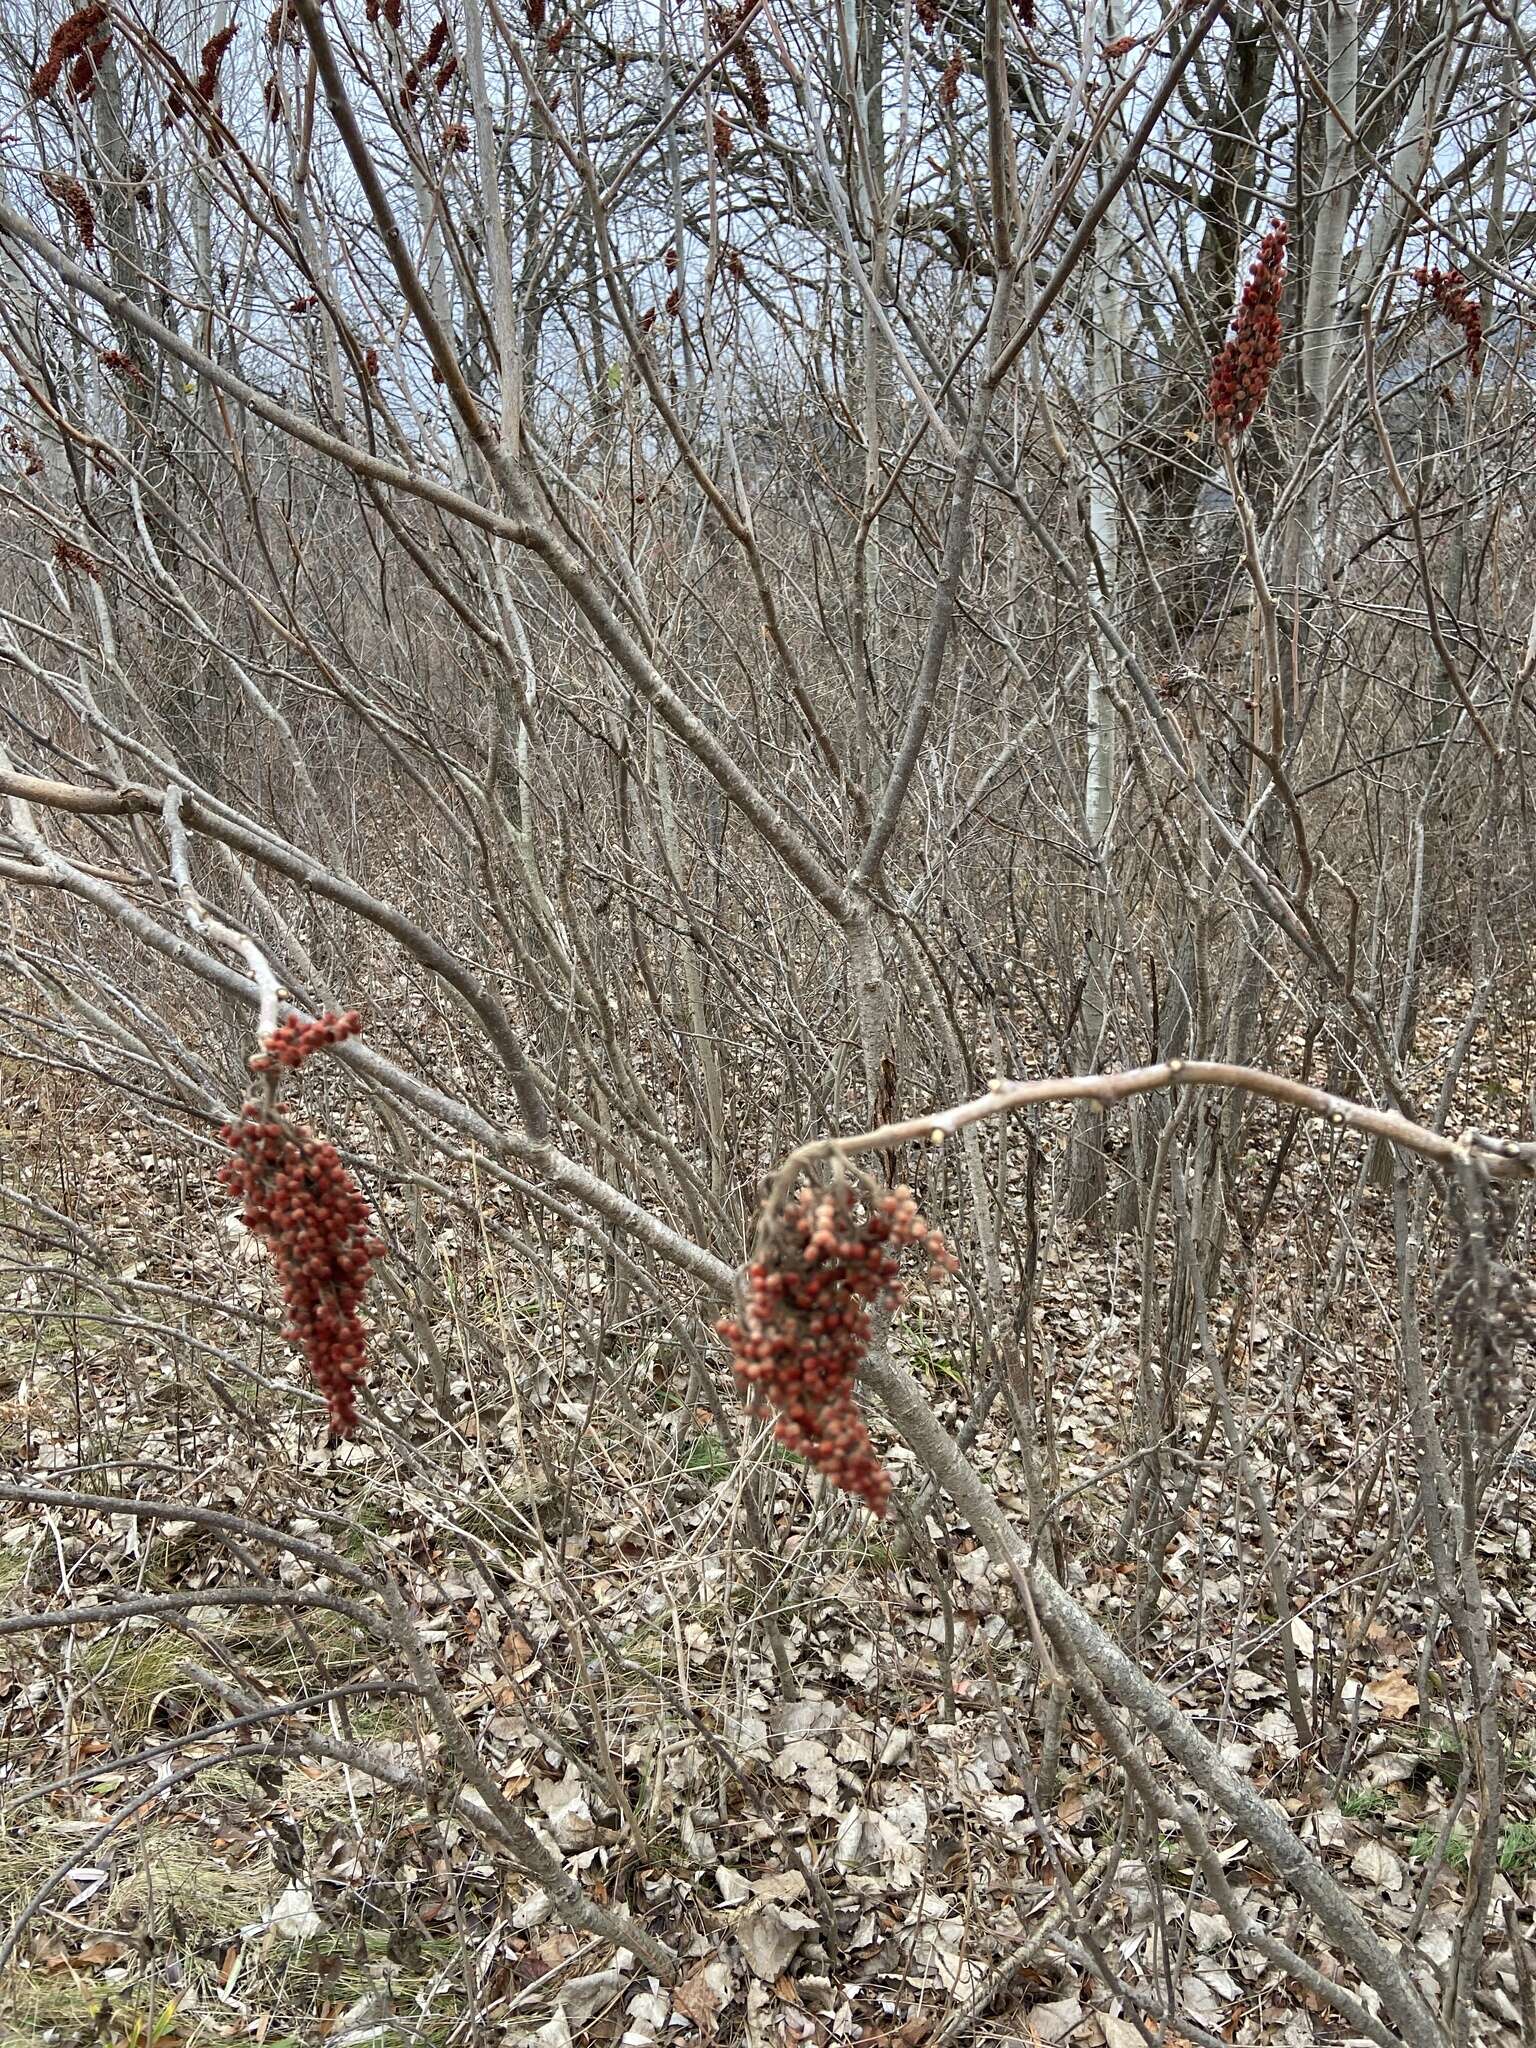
219 1010 385 1436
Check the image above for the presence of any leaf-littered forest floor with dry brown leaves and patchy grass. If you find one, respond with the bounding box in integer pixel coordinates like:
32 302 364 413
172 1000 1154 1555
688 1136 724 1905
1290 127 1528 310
0 1004 1536 2048
